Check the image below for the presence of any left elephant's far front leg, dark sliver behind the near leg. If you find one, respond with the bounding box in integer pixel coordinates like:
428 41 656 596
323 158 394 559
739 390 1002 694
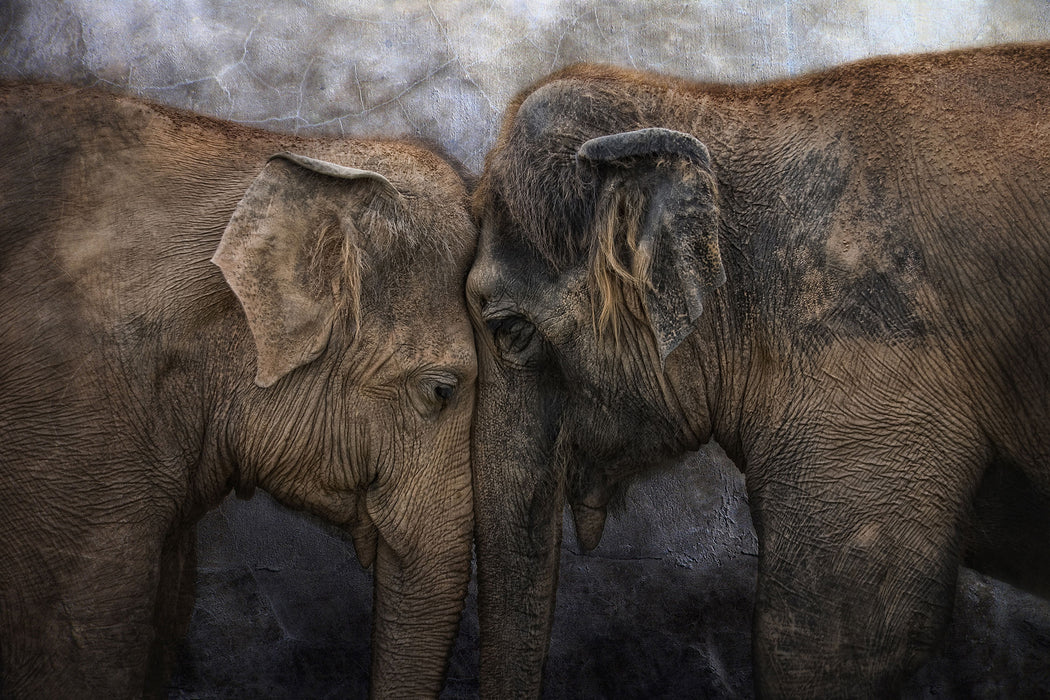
145 524 196 698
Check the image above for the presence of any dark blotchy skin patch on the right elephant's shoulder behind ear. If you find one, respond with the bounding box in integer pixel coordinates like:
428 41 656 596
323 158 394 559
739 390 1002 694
758 137 928 346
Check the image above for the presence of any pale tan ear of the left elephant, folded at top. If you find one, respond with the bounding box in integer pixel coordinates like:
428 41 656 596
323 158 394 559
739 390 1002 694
212 153 400 387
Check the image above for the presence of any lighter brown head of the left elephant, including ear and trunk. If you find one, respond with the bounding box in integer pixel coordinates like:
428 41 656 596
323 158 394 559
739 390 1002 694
213 144 476 697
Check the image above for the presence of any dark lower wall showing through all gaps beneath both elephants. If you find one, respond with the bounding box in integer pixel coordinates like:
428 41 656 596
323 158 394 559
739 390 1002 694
170 446 1050 700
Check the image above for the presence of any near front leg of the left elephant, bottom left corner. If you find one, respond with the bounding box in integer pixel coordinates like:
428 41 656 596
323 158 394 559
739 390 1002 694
0 523 160 698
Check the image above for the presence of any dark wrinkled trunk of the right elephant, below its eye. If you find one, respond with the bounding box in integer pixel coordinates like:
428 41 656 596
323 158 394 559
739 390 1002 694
473 369 565 698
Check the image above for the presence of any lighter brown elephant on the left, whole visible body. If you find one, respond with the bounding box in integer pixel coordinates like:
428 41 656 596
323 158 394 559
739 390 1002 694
0 83 477 698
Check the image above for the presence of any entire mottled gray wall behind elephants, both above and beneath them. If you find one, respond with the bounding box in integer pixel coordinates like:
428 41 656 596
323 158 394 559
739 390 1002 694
0 0 1050 698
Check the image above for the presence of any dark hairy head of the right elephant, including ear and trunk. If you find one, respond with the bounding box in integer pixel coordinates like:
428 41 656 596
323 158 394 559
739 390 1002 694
467 81 726 697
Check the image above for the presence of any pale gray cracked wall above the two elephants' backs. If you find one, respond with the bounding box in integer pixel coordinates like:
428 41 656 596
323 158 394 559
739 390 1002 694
8 0 1050 170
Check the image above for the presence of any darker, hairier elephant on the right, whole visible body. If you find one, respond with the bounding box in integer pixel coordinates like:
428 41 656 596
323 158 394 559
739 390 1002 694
467 44 1050 698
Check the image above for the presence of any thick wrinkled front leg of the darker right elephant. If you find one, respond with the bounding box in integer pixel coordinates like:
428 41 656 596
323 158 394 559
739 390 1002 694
748 432 977 697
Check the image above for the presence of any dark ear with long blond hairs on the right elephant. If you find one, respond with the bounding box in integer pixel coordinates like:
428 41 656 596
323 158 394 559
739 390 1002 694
576 128 726 367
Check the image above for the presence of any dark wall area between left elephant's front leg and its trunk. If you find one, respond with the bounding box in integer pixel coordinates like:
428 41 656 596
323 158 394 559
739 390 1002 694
170 492 372 698
